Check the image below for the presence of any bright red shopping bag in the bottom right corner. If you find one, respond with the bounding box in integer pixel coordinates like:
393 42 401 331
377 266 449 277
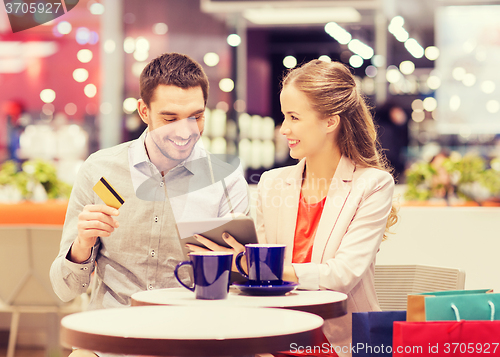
392 320 500 357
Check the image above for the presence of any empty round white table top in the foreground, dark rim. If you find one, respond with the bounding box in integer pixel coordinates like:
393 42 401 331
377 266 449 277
61 306 323 356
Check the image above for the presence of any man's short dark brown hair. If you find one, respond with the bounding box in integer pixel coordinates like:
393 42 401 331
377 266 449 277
139 52 208 108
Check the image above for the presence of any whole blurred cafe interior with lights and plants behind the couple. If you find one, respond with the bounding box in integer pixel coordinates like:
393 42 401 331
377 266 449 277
0 0 500 357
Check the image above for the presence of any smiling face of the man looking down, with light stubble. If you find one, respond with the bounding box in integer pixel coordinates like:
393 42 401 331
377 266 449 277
138 85 205 166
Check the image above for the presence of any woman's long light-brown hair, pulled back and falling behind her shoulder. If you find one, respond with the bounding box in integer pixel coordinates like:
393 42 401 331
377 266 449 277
282 60 398 239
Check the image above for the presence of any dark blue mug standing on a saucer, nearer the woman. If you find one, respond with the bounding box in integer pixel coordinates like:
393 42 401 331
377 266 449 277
235 244 286 285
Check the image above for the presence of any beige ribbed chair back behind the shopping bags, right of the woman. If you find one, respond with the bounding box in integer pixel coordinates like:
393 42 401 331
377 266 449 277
375 265 465 311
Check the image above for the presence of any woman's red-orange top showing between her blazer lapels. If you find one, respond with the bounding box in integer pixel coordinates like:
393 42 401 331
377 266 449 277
292 192 326 263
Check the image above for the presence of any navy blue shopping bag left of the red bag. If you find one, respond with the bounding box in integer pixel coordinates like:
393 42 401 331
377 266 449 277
352 311 406 357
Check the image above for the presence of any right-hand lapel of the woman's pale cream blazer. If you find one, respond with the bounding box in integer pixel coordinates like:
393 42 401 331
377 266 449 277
311 156 355 263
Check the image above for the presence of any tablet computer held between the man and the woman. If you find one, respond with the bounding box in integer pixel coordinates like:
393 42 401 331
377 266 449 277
177 216 258 248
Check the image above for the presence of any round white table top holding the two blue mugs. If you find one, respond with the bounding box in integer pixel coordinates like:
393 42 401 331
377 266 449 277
132 286 347 319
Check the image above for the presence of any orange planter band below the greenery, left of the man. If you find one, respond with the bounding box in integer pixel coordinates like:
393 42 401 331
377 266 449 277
0 200 68 225
